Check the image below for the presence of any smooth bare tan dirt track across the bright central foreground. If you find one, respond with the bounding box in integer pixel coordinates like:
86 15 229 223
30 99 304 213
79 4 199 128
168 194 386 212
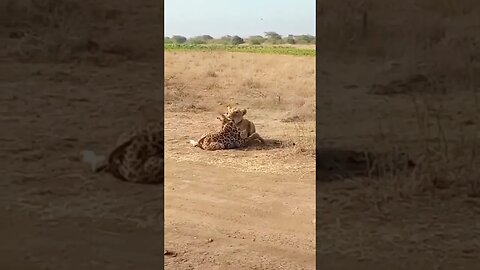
165 159 315 269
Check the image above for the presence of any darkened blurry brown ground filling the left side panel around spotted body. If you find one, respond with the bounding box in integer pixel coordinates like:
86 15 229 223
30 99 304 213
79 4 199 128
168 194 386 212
0 1 163 269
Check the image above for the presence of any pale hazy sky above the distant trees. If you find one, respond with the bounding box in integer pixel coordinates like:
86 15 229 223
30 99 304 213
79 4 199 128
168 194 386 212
165 0 315 38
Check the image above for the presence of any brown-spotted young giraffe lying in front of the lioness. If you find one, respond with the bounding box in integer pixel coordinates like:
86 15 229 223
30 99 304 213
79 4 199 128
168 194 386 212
190 115 259 151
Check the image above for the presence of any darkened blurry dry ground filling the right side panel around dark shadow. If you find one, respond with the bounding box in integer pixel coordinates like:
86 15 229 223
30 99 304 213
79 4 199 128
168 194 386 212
317 0 480 268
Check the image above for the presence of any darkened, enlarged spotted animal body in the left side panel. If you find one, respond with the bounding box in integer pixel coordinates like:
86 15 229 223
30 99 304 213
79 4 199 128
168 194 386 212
96 123 164 184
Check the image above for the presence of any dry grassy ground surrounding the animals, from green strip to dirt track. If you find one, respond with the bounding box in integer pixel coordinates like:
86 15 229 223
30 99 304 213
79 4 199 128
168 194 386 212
165 52 315 174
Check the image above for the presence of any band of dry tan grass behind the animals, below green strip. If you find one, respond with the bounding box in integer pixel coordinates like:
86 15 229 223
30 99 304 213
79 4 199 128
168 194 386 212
165 52 315 120
